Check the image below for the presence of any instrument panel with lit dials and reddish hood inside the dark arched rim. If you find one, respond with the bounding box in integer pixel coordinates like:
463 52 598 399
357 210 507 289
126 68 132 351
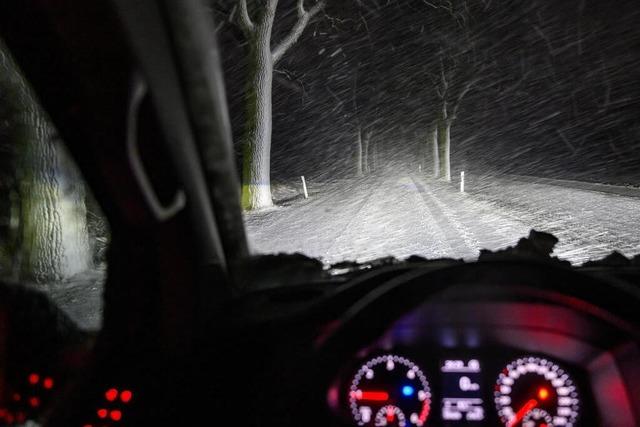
326 280 638 427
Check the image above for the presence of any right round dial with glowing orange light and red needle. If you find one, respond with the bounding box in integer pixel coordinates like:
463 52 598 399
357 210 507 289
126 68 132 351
494 357 580 427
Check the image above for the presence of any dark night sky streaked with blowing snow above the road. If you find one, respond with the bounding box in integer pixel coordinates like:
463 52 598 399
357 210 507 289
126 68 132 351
213 0 640 185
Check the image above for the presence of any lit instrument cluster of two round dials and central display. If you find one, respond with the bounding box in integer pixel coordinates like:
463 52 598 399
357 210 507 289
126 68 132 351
329 349 597 427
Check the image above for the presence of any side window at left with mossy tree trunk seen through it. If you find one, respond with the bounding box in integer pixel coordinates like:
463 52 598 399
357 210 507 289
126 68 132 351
0 41 109 329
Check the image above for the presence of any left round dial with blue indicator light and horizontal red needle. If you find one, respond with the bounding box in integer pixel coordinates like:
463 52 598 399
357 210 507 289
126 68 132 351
349 355 431 427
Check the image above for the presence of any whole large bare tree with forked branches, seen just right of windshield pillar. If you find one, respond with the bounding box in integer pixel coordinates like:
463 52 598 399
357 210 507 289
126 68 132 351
236 0 325 210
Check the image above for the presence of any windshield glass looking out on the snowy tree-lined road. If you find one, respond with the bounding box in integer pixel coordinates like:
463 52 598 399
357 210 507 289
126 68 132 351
213 0 640 264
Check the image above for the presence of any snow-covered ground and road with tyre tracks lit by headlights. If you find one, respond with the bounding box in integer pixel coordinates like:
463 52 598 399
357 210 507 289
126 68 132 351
246 174 640 264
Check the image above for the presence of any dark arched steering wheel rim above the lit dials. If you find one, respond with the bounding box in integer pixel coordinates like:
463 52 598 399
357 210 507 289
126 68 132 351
294 260 640 426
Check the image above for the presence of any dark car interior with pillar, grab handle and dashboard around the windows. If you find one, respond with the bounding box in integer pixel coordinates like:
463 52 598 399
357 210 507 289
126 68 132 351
0 0 640 427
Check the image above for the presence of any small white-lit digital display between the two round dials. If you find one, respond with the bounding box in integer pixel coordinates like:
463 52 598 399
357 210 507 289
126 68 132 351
440 359 485 425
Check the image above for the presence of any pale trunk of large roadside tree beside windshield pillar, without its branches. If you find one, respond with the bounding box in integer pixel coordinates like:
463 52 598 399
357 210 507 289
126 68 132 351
242 32 273 210
